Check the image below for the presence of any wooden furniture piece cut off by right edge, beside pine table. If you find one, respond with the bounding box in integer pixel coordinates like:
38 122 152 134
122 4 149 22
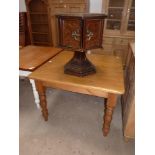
122 43 135 139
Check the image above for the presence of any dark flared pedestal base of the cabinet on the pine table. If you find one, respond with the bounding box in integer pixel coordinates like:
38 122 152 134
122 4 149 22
64 51 96 76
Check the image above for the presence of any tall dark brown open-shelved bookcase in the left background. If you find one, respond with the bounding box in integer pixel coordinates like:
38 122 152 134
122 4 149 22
25 0 52 46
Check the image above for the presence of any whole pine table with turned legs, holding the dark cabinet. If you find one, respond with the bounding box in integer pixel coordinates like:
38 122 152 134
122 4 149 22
29 51 124 136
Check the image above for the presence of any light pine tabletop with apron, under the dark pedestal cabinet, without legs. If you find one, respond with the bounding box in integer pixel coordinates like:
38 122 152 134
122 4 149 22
29 51 124 97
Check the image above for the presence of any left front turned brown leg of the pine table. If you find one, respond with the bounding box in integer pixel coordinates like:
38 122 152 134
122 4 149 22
35 81 48 121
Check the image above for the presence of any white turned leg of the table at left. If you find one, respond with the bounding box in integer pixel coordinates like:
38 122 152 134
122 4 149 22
30 79 40 109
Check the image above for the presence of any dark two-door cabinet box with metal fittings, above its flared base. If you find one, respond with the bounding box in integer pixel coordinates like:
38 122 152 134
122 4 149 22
56 13 106 51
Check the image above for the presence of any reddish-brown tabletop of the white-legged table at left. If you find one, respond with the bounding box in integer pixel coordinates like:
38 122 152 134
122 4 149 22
19 45 62 71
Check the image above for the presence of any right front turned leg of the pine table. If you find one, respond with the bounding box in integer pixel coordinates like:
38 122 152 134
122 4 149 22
102 94 117 136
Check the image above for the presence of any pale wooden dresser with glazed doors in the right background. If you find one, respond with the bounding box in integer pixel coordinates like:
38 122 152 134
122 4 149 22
93 0 135 68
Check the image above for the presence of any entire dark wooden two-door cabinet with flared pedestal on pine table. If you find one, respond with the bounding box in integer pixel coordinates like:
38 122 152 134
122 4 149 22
57 13 106 76
